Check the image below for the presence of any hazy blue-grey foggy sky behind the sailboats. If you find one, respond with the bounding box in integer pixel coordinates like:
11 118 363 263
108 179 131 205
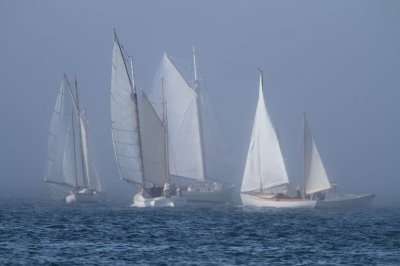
0 0 400 206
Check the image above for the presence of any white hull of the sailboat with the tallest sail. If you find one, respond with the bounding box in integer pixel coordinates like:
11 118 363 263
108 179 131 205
132 192 187 208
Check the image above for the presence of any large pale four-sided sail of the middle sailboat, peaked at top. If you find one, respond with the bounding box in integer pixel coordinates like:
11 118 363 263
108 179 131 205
147 53 205 180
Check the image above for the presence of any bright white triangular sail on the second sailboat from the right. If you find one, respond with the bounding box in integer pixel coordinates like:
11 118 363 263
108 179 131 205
241 74 289 192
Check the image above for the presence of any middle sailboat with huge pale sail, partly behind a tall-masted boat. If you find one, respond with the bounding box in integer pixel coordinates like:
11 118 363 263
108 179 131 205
144 50 233 202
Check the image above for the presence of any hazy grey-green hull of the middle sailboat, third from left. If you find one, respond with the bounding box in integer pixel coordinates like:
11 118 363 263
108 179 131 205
182 186 234 203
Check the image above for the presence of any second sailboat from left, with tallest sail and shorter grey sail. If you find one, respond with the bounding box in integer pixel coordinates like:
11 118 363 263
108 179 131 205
111 31 186 207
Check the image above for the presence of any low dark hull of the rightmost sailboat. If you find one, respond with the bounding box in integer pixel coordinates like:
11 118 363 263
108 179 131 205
316 194 375 209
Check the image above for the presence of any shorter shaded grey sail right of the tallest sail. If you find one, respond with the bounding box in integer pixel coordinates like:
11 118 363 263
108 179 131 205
140 93 167 185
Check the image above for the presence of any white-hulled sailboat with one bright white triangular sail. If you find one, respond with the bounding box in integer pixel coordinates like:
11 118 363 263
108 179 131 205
240 71 316 208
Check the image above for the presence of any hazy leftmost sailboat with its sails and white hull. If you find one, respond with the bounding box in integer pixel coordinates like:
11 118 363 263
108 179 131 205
43 75 101 203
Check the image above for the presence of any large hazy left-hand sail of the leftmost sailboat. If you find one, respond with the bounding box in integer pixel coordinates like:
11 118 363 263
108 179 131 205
44 76 75 186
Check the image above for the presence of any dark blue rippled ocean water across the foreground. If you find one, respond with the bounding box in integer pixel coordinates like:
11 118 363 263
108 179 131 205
0 200 400 265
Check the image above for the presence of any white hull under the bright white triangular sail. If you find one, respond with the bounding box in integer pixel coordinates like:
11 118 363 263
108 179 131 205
240 193 316 209
